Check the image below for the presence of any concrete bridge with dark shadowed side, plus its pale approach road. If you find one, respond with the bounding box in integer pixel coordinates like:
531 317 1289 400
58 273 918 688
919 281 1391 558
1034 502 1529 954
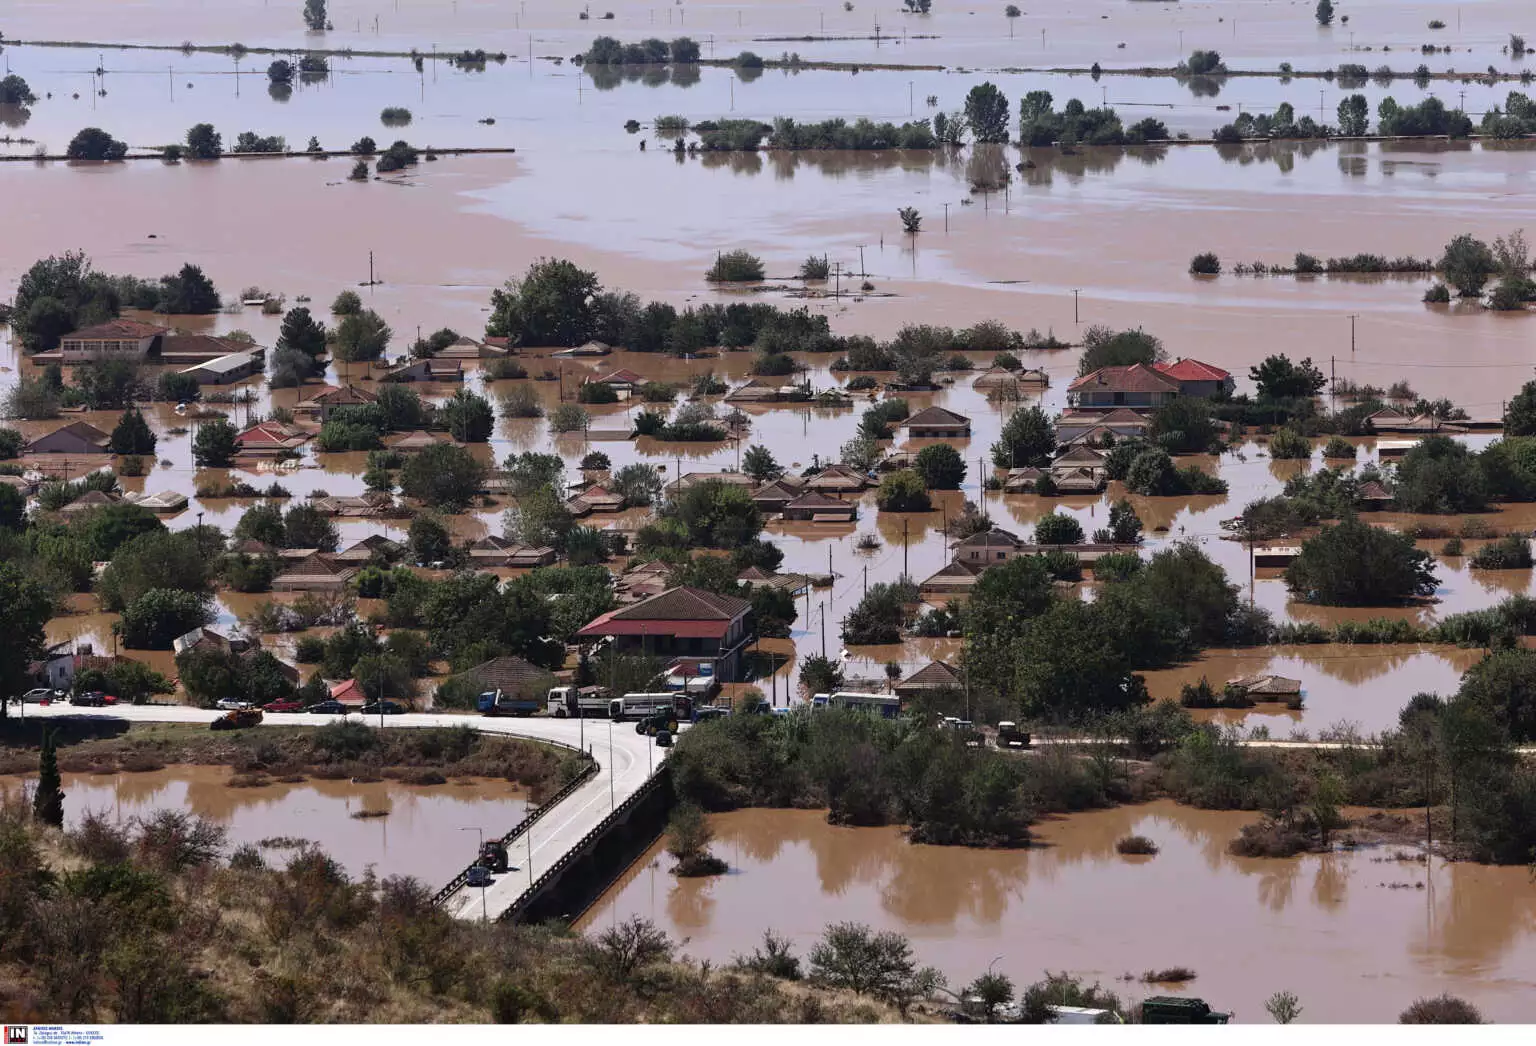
11 703 668 919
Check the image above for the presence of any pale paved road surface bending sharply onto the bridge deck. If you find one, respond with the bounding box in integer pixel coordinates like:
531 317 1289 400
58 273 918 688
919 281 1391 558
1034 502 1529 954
11 705 668 919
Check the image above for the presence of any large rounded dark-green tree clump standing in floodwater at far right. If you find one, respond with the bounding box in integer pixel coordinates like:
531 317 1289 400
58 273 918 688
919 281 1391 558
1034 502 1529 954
1286 518 1436 607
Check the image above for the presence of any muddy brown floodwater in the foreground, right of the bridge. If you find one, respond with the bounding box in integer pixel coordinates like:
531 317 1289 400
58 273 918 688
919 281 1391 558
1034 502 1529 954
582 802 1536 1023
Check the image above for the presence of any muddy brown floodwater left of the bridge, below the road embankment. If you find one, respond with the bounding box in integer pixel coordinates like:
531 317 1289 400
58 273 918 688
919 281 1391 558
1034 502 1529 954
0 766 527 889
